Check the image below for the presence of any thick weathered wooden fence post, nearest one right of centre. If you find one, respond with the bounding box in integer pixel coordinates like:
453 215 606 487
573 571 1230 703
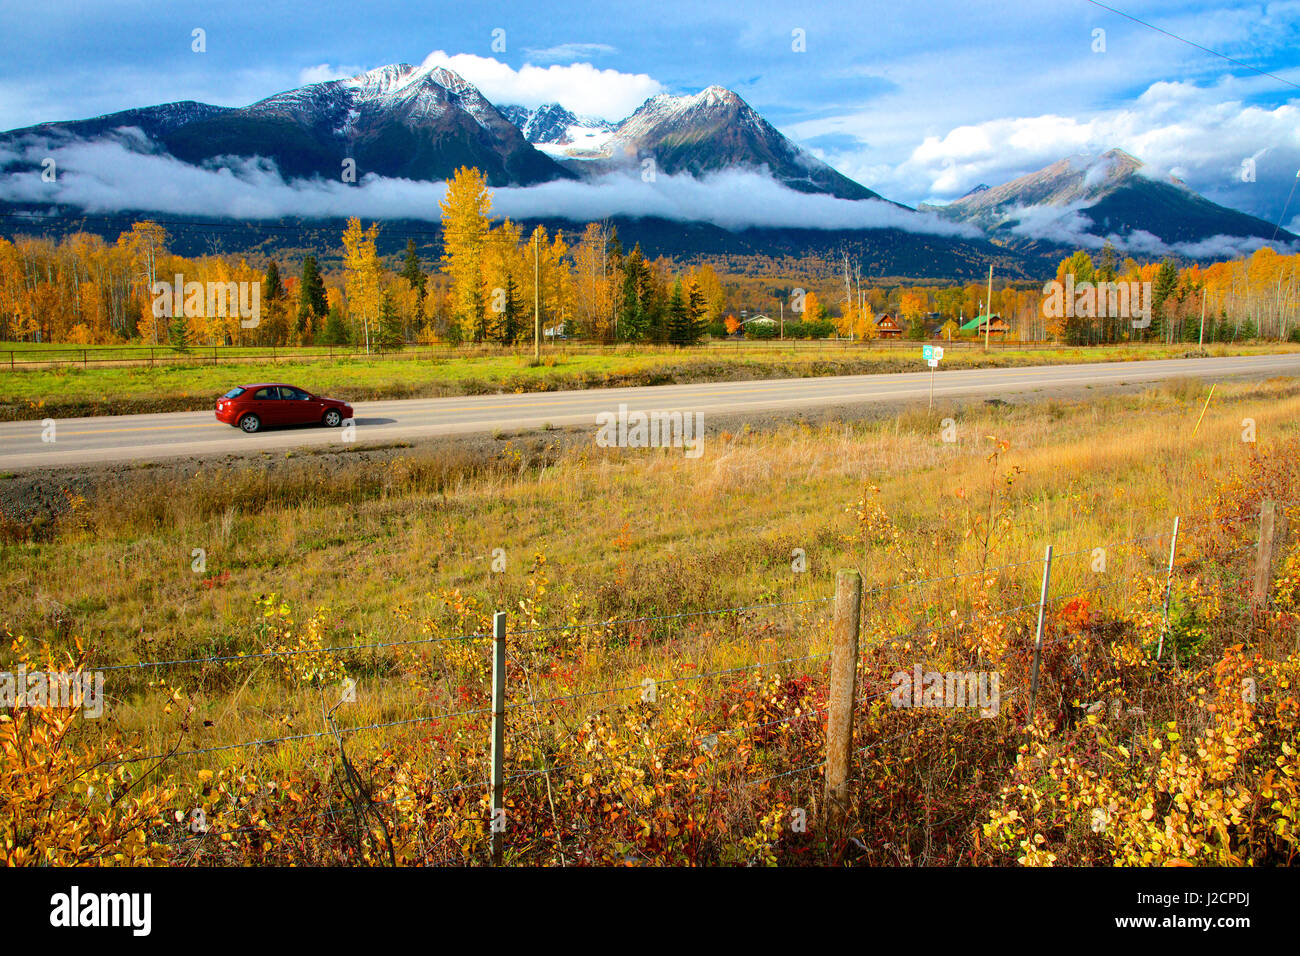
826 570 862 826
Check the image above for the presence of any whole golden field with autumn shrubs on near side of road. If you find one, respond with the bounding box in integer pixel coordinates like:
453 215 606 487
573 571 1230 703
0 380 1300 864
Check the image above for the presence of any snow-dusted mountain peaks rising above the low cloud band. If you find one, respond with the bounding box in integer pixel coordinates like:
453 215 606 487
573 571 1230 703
0 64 1296 272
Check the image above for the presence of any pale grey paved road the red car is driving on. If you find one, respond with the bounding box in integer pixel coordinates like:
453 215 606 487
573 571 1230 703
0 350 1300 471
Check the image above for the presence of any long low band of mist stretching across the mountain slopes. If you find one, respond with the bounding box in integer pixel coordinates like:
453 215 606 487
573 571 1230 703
0 131 980 238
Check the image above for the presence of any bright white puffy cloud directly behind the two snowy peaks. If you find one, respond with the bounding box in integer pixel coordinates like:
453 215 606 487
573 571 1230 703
423 49 664 120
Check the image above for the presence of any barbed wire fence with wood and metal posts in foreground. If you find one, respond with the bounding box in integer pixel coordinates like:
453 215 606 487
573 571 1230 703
50 499 1300 864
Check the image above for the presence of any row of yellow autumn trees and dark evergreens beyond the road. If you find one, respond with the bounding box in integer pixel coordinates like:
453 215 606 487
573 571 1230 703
0 176 1300 350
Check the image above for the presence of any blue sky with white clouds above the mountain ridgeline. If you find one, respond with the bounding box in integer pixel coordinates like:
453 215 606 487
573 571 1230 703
0 0 1300 228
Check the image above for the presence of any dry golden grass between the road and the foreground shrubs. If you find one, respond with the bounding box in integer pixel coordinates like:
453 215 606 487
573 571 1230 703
0 380 1300 765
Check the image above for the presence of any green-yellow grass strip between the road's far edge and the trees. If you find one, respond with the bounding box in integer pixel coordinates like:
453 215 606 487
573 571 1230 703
0 343 1300 420
